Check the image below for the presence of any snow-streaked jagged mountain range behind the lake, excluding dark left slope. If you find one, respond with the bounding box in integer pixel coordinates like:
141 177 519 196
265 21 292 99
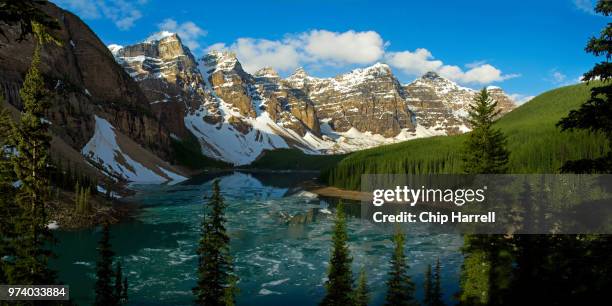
109 32 514 165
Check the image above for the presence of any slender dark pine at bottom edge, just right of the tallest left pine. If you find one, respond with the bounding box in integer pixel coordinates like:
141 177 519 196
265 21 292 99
94 223 116 306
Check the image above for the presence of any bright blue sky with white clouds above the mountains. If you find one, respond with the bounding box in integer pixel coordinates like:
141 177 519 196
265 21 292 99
52 0 610 103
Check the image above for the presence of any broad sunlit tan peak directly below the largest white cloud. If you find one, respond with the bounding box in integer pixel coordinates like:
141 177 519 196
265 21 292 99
286 63 415 137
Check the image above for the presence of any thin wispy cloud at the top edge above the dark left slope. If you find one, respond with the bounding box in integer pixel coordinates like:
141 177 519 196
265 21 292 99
56 0 147 31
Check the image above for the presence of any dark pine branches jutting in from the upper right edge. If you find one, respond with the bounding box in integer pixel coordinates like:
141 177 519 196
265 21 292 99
557 0 612 173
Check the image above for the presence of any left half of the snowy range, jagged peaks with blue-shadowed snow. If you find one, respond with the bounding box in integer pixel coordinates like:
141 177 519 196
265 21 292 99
109 43 328 164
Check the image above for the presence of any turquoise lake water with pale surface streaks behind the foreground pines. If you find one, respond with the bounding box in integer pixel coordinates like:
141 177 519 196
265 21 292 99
52 172 463 306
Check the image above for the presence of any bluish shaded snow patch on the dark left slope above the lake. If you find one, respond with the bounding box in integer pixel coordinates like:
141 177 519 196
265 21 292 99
81 116 186 184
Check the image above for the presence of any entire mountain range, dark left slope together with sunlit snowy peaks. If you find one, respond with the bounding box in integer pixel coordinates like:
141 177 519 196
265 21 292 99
0 5 515 182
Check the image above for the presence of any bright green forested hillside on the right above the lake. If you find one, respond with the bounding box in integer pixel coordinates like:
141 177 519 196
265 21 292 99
322 83 607 189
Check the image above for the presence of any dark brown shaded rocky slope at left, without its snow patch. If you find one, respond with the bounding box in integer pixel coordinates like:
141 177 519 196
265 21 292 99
0 4 184 183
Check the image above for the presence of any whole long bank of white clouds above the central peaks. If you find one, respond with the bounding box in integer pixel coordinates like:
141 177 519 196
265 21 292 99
208 30 519 84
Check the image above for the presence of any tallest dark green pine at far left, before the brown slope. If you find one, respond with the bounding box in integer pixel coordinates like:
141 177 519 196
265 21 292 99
9 31 55 284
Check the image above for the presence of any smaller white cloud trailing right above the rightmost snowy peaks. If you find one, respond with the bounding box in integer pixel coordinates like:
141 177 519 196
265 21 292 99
386 48 518 84
